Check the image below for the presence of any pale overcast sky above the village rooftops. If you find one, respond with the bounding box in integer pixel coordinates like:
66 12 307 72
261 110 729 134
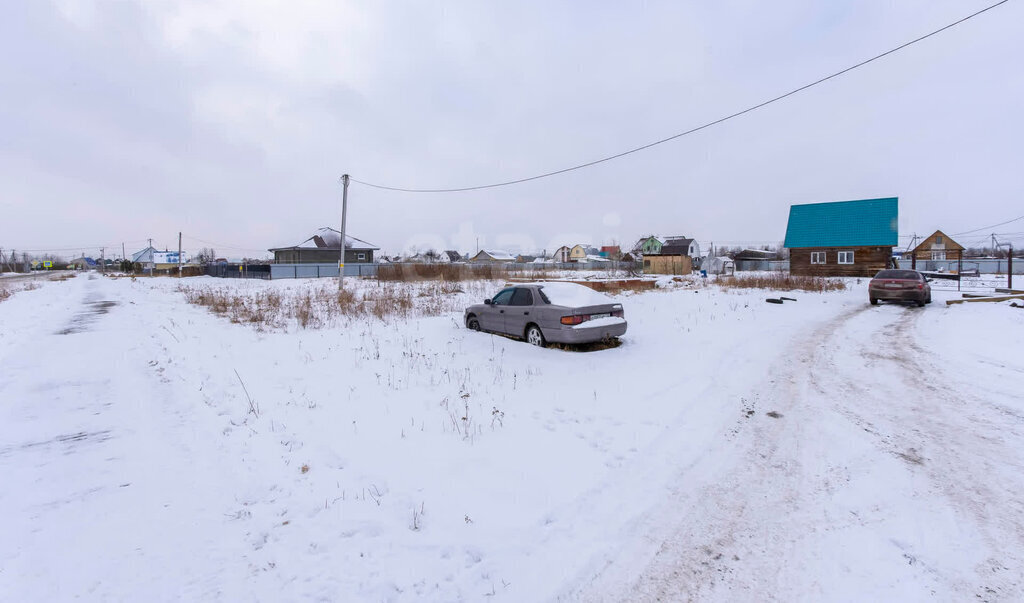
0 0 1024 257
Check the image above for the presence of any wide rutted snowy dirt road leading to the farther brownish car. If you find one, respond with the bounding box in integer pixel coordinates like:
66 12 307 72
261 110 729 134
566 304 1024 601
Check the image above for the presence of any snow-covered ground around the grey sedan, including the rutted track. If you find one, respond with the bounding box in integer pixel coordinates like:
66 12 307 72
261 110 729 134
0 274 1024 601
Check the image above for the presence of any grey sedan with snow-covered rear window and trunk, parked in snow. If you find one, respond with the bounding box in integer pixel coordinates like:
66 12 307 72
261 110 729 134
464 283 626 346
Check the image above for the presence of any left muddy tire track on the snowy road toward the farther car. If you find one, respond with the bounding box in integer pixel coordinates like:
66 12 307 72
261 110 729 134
568 306 868 601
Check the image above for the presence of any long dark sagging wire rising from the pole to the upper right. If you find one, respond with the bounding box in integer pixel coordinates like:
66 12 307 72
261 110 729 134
350 0 1010 192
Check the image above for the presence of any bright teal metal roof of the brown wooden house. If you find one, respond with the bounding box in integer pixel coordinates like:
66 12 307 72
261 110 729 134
784 197 899 248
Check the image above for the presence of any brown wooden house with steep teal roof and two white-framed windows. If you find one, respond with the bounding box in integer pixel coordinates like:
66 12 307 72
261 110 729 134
785 197 899 276
